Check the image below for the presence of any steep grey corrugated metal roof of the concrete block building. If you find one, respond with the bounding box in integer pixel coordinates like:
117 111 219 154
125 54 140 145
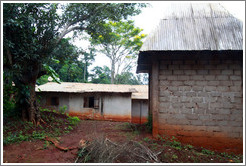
140 3 243 51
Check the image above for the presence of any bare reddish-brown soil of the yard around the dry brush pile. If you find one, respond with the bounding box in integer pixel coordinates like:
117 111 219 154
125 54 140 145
3 116 243 163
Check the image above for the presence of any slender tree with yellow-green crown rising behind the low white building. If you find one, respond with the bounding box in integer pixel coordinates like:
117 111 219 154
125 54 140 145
91 21 146 84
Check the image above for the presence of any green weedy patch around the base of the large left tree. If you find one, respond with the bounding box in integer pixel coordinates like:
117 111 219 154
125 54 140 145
3 108 80 145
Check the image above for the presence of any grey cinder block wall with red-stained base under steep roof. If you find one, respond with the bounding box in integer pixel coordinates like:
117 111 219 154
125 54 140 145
158 60 243 153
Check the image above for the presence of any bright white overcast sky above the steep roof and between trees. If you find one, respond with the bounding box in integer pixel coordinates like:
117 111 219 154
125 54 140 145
70 1 245 72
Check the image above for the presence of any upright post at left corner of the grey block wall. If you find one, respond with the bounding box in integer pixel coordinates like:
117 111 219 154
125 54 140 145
150 58 159 137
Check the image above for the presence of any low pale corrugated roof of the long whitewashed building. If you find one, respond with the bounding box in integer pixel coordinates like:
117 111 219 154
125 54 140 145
35 82 148 99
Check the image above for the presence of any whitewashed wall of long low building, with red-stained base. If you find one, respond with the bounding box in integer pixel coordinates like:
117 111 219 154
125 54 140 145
39 92 131 122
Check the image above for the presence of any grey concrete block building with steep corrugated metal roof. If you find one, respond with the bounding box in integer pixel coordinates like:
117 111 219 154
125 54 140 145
137 3 243 153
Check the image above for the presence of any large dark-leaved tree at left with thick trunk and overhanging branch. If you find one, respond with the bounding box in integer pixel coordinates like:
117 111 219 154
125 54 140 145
3 3 144 125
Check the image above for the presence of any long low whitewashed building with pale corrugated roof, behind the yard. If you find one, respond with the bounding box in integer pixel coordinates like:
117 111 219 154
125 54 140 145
36 82 148 124
